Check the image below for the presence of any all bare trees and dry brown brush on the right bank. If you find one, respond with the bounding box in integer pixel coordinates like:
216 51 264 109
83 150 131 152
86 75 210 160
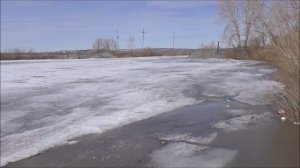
220 0 300 122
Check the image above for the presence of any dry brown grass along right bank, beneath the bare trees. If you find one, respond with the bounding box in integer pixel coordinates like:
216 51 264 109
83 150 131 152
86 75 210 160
225 45 300 122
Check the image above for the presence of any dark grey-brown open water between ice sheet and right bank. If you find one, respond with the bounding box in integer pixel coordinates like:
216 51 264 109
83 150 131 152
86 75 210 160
5 100 299 167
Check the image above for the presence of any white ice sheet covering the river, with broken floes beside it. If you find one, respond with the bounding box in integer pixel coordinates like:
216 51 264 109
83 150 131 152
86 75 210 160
1 56 283 166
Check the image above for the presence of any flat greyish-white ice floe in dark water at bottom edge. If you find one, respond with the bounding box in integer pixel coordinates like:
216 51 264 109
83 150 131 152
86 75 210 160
150 142 238 168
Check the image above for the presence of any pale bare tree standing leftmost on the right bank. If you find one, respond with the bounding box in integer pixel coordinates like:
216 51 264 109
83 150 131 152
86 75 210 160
219 0 263 49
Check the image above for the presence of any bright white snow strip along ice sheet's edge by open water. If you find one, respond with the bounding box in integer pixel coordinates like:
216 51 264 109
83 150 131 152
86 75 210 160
1 99 195 165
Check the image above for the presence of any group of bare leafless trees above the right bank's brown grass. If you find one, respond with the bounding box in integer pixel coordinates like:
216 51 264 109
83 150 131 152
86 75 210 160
219 0 299 69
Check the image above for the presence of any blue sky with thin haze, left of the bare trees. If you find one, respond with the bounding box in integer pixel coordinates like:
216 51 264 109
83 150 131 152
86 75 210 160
1 0 223 51
